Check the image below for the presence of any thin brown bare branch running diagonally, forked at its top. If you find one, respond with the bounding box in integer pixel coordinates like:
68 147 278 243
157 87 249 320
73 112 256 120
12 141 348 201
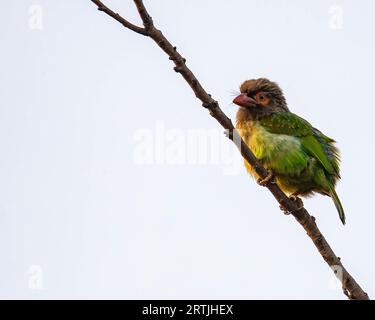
91 0 369 300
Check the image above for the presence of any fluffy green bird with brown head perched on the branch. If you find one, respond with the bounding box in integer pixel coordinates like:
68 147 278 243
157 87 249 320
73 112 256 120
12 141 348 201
233 78 345 224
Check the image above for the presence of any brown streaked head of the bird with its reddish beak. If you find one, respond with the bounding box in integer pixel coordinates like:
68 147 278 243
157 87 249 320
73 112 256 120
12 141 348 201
233 78 289 119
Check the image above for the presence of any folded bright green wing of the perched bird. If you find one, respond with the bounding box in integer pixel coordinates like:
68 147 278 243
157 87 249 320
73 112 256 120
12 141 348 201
260 112 336 174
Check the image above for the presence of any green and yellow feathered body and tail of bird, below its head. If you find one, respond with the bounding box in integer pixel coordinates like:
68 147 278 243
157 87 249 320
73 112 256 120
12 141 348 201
238 112 345 224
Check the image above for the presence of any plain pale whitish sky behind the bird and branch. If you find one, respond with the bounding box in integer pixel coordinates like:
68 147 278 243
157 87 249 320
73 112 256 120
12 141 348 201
0 0 375 299
